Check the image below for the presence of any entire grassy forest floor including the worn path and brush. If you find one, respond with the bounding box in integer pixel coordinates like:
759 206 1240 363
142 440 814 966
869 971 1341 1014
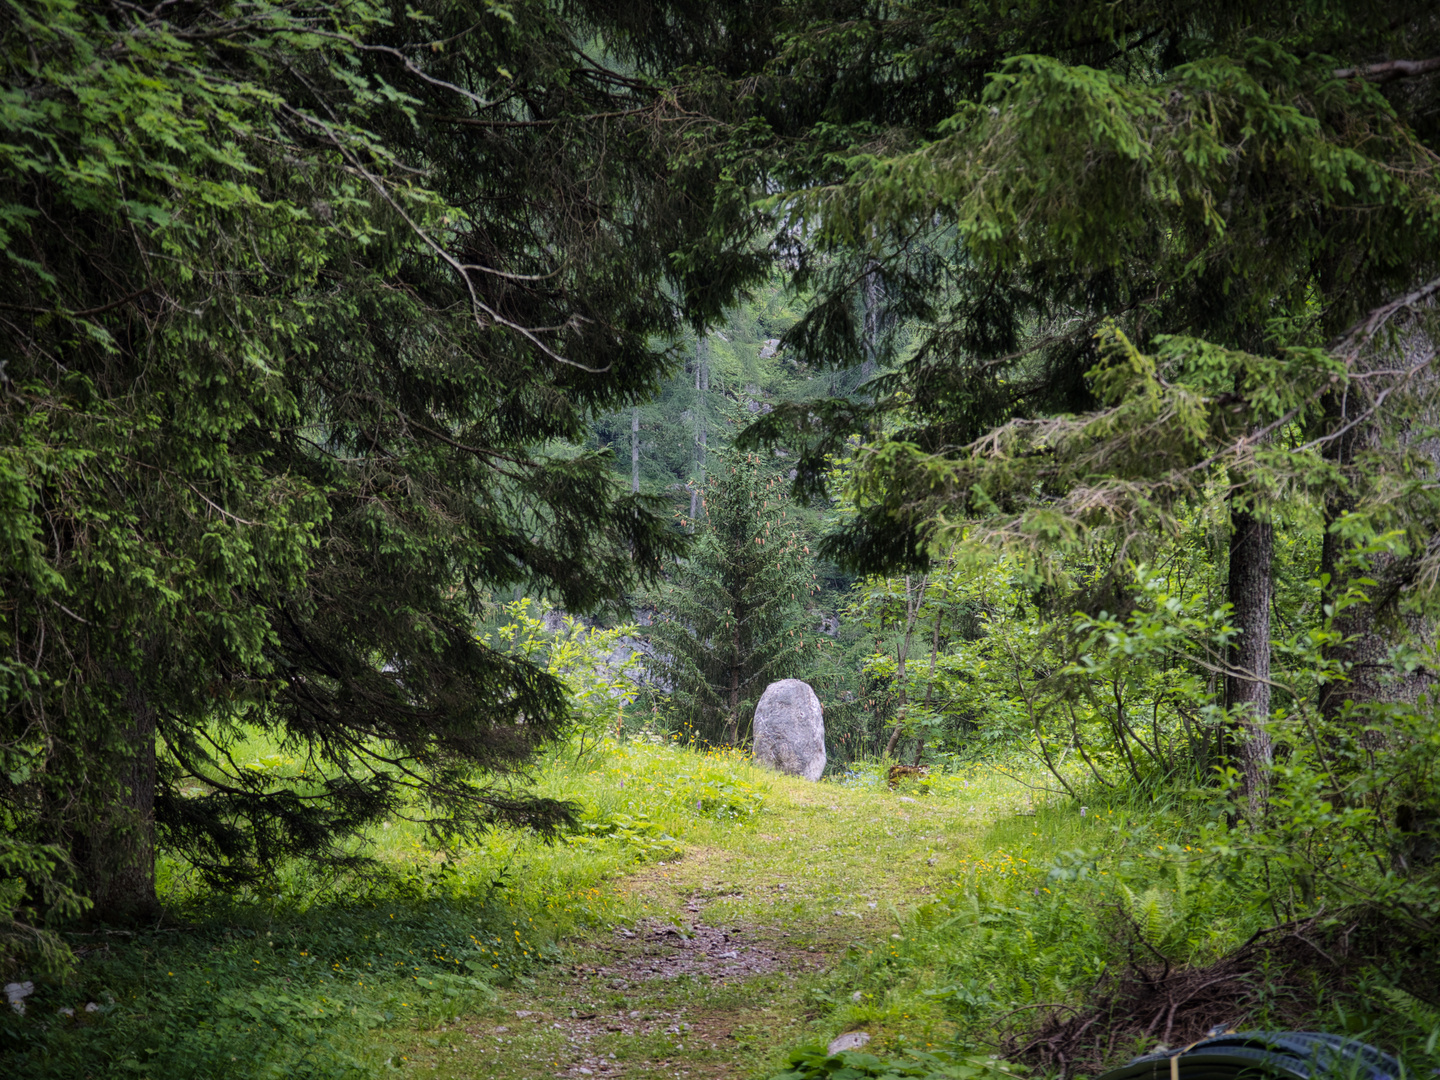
11 736 1440 1080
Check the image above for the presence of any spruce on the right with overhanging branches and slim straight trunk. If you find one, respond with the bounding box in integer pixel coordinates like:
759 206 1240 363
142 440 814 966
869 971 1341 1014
725 0 1440 806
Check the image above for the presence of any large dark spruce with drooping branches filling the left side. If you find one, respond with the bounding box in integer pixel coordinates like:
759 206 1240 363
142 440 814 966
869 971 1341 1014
0 0 765 933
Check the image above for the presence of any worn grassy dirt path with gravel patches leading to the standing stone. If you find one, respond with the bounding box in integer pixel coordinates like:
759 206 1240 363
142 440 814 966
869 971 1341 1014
397 782 1025 1080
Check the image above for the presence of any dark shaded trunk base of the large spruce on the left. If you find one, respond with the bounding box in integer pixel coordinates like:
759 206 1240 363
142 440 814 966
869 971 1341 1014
71 671 160 923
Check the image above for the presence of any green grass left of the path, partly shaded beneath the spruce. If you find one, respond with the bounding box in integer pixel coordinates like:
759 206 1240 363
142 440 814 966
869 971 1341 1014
0 739 768 1080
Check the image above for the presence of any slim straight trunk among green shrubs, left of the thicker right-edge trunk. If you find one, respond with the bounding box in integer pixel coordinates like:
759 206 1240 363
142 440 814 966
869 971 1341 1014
1225 508 1274 819
